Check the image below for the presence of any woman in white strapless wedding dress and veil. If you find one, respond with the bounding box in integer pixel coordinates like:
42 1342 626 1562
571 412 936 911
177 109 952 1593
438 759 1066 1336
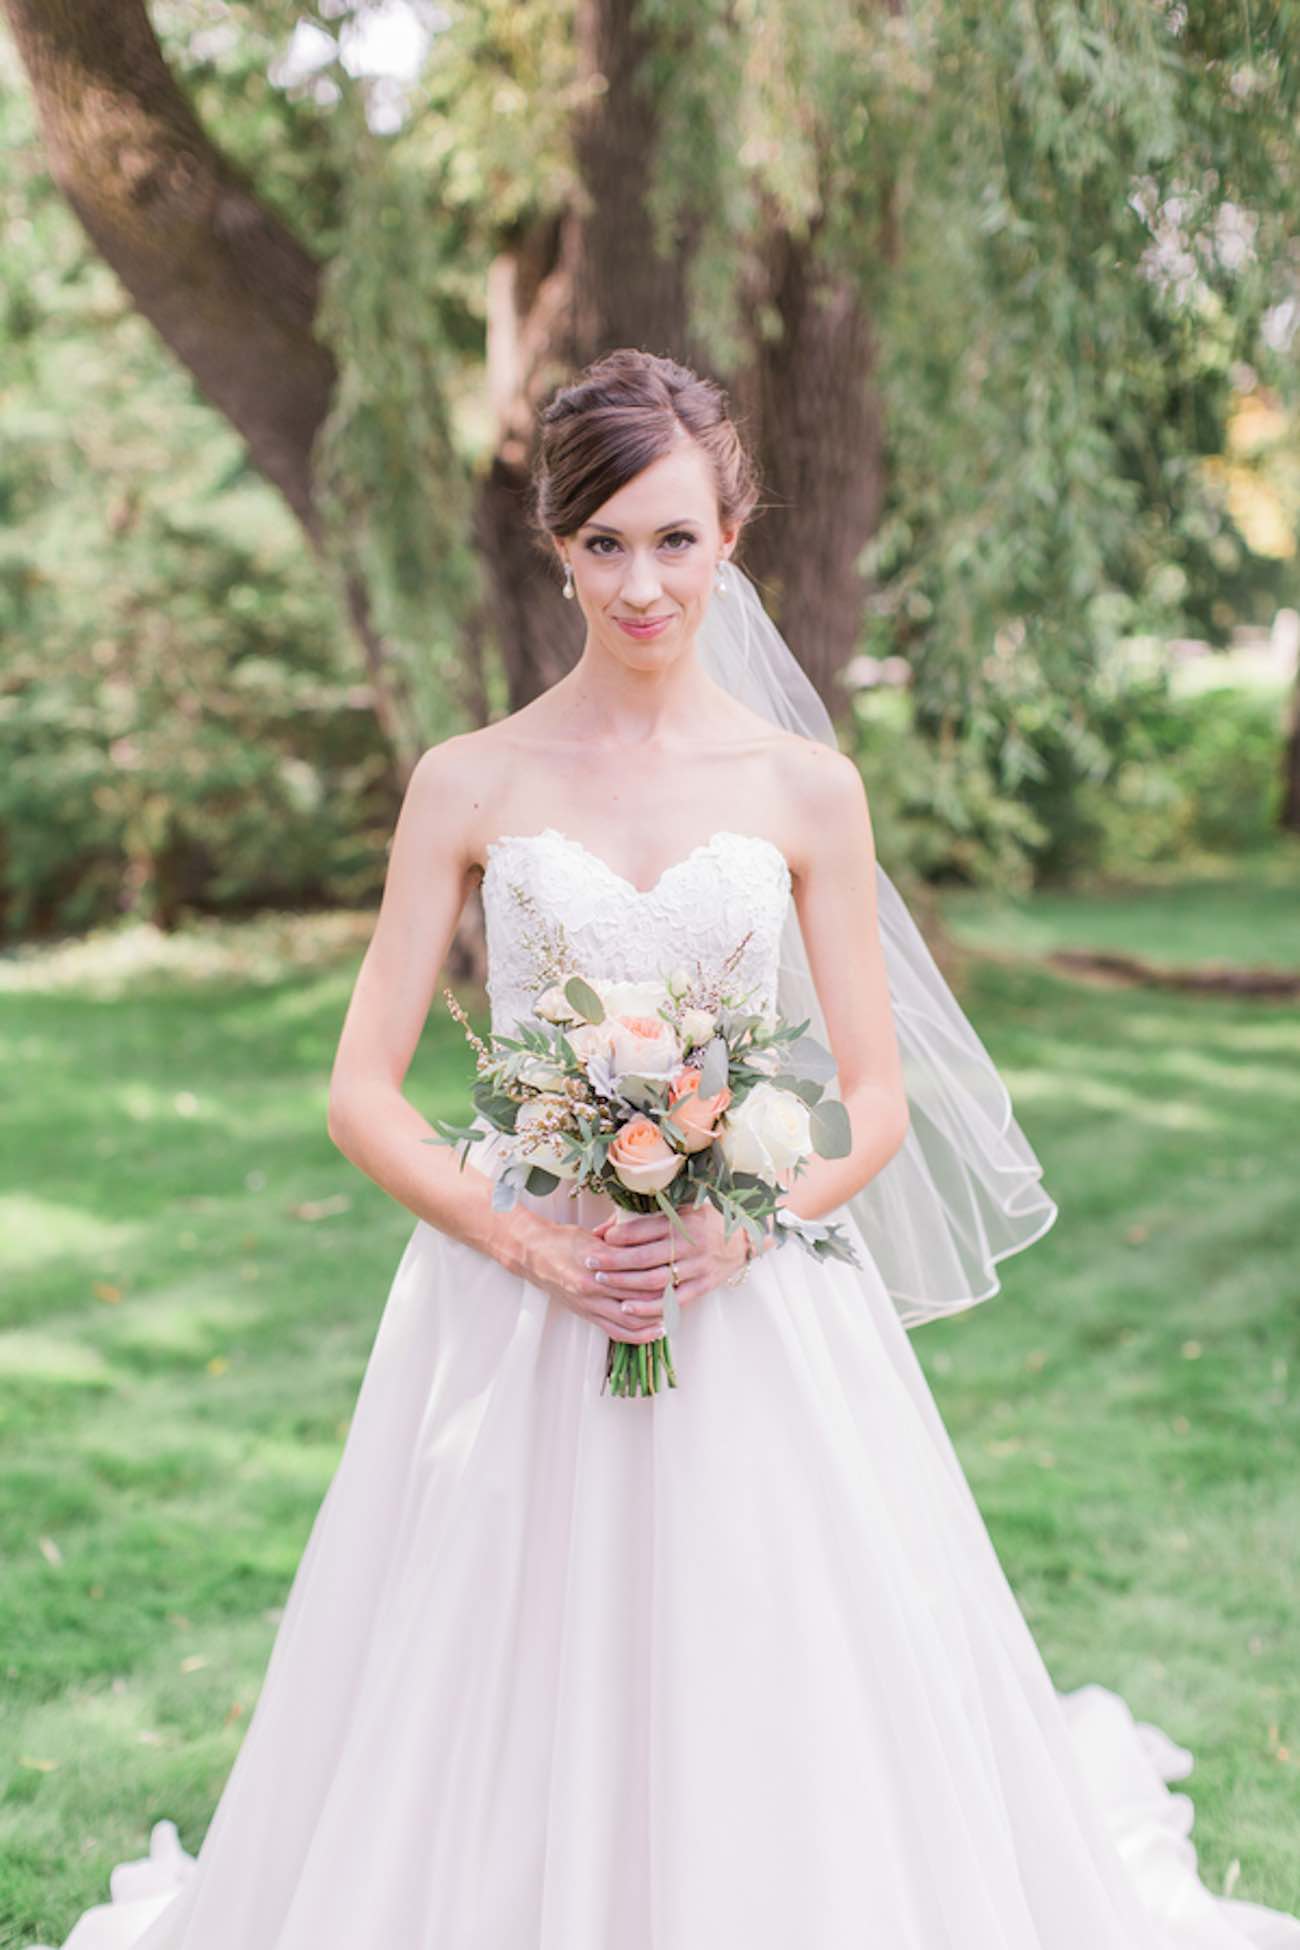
38 349 1300 1950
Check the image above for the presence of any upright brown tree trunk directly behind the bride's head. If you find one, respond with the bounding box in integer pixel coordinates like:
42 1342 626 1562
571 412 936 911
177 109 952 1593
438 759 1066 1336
467 0 887 714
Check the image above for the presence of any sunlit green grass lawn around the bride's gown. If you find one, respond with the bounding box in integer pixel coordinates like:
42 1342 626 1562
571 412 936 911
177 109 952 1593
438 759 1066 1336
0 883 1300 1950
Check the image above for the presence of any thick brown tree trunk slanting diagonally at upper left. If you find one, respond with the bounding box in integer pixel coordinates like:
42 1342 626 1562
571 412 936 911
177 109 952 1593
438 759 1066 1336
0 0 415 782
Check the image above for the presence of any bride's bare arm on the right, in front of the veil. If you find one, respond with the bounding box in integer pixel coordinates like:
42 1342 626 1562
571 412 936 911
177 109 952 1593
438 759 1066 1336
784 739 908 1219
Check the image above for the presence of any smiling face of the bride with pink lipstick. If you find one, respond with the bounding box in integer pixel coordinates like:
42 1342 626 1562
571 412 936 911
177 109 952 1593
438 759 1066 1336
559 437 737 671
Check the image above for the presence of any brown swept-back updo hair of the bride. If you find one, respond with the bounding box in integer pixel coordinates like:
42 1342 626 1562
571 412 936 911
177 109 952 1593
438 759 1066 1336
532 345 758 562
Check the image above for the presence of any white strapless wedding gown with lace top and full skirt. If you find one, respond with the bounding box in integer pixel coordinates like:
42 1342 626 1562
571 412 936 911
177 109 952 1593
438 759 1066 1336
33 827 1300 1950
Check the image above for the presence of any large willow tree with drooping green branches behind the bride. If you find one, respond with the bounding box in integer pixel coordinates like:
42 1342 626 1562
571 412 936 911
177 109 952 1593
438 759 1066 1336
4 0 1300 799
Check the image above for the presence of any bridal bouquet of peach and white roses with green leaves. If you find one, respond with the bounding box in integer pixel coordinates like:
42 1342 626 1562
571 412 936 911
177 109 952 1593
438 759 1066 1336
423 954 860 1394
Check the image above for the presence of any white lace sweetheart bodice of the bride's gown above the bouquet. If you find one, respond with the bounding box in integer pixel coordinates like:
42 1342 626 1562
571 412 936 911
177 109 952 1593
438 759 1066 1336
481 827 791 1035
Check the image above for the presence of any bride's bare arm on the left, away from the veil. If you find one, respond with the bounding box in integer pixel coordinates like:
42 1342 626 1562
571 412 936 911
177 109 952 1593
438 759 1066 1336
327 733 548 1275
